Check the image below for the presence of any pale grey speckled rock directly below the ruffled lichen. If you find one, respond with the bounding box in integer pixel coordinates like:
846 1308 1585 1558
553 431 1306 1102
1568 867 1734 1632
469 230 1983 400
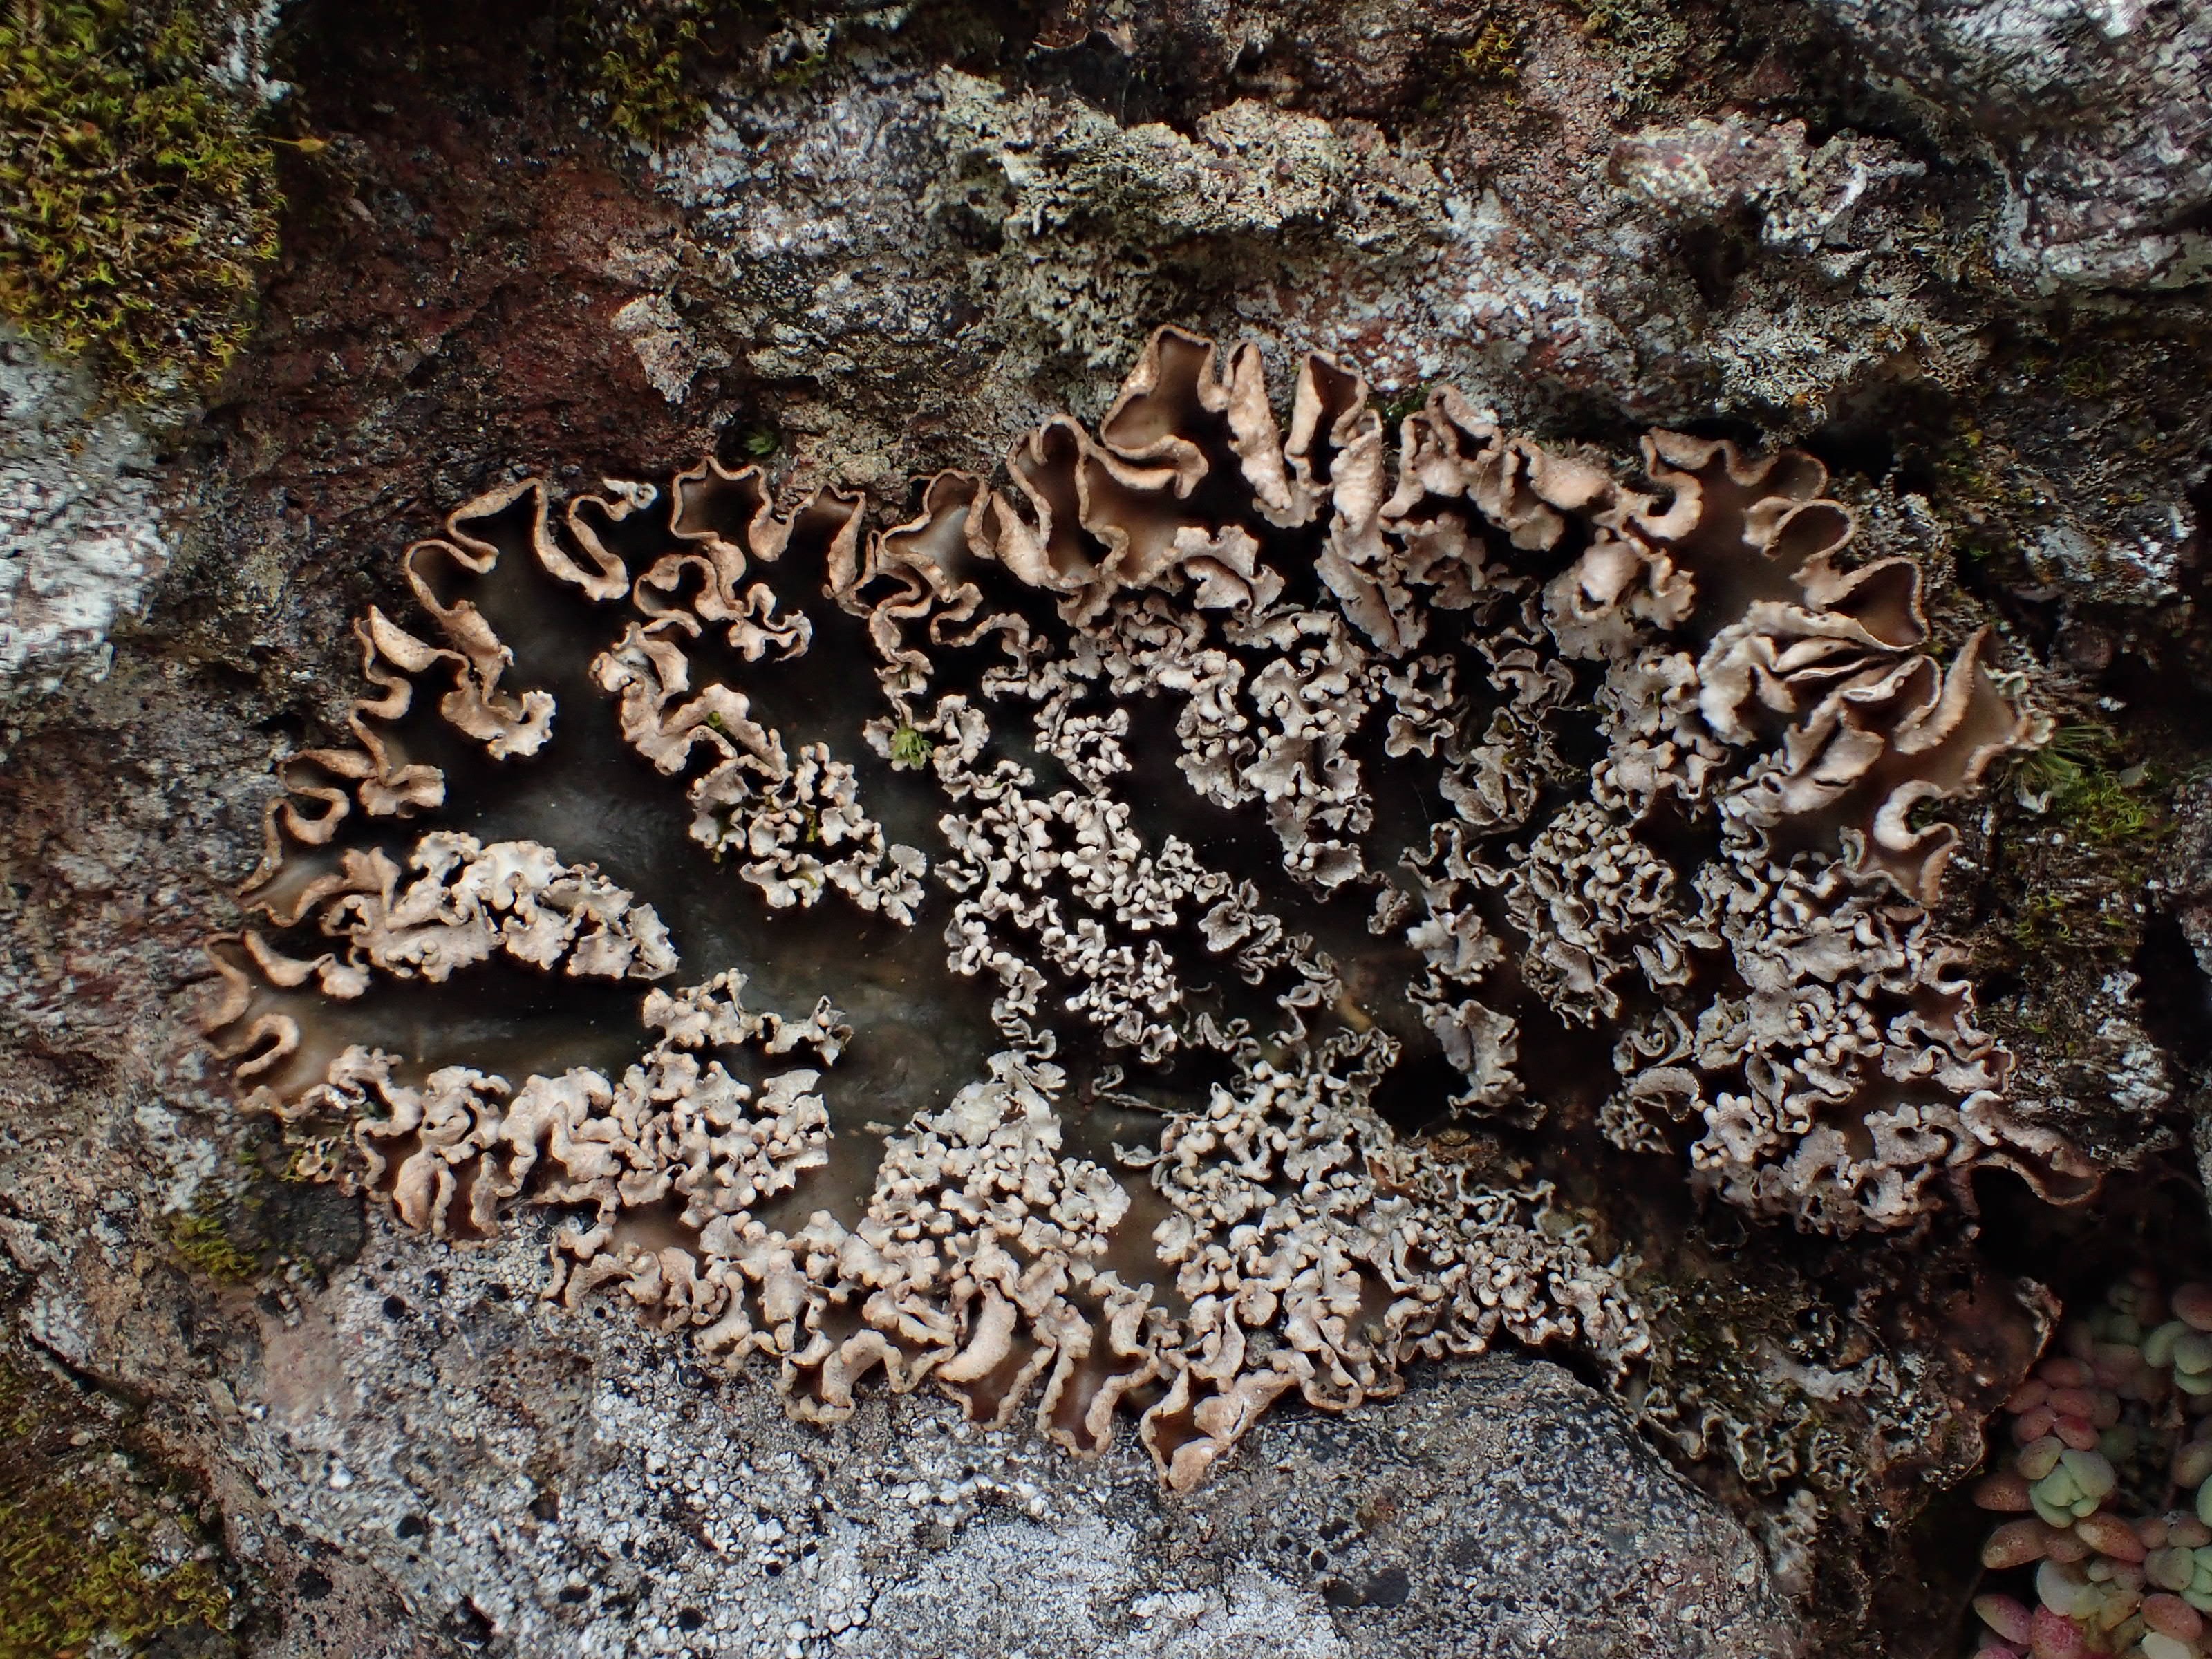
216 1221 1801 1659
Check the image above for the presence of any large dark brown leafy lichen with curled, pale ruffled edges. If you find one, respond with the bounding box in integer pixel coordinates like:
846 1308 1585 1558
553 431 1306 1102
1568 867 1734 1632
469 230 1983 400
199 330 2086 1486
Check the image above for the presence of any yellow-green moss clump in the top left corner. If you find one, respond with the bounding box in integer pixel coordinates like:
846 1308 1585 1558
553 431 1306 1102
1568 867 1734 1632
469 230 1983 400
0 0 281 396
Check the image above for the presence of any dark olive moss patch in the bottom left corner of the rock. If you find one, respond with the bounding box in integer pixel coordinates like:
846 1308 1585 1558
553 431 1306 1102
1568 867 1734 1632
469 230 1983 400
0 1360 232 1659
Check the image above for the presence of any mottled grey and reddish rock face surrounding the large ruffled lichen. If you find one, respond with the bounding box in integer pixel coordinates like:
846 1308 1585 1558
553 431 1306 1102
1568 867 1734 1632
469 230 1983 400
0 0 2212 1659
